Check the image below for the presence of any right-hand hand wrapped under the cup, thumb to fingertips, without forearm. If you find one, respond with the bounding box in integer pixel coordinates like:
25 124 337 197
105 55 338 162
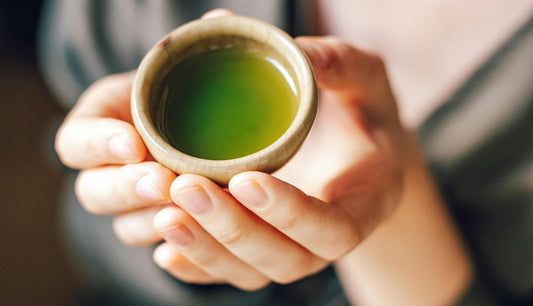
154 38 405 290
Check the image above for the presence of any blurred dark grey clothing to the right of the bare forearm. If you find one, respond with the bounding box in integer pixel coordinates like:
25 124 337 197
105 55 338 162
419 18 533 305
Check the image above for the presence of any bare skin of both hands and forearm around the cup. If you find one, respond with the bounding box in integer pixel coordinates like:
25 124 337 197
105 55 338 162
56 10 471 305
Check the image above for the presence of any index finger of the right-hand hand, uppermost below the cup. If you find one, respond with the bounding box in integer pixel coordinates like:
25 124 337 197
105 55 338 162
229 172 370 260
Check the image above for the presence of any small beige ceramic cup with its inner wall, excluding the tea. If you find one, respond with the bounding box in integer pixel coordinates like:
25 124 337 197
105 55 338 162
131 16 317 185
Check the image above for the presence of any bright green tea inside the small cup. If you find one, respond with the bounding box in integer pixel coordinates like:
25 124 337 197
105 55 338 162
161 48 298 160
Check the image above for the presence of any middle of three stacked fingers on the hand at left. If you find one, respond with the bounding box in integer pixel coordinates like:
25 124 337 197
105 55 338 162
76 162 176 214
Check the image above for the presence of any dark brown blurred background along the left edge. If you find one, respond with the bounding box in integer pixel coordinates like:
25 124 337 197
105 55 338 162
0 0 77 305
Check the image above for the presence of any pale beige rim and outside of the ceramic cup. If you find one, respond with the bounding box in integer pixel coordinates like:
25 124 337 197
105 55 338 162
131 16 317 185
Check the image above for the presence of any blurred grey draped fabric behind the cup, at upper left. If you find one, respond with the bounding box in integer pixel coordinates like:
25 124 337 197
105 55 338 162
38 0 286 109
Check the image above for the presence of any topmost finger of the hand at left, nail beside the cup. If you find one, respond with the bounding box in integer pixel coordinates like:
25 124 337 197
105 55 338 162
56 118 146 169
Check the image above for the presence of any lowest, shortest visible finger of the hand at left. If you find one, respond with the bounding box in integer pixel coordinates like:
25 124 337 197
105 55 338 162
113 204 168 246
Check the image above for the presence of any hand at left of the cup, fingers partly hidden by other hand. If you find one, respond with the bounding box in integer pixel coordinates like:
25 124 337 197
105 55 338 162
55 72 176 245
